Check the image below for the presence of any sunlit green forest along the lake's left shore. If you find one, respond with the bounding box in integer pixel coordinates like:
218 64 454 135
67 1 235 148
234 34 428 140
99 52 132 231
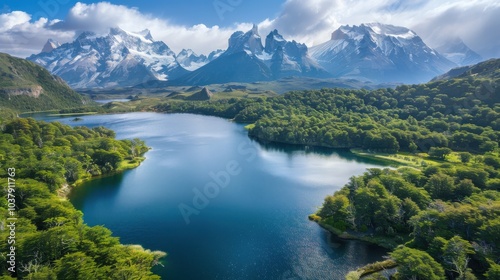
0 118 165 280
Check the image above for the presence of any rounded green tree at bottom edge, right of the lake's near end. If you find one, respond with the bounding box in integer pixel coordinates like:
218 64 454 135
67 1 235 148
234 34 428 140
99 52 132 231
391 247 445 280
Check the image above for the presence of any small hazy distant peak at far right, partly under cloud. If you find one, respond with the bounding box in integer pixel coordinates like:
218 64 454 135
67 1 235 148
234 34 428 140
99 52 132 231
436 37 483 66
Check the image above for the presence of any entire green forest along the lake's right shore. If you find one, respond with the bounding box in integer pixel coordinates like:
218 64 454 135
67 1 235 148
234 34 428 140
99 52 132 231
154 72 500 280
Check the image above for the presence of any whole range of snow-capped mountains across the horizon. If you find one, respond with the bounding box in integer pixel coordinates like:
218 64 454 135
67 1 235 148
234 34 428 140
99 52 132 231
28 23 481 88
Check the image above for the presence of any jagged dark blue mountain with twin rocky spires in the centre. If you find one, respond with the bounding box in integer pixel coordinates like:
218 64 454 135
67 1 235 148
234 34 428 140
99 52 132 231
176 25 328 85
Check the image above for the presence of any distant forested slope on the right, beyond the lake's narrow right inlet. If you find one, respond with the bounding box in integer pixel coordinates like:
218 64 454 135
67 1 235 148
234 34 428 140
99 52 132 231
155 78 500 153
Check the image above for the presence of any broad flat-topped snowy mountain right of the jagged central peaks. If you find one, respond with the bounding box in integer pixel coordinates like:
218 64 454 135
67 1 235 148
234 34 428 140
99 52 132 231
310 23 456 83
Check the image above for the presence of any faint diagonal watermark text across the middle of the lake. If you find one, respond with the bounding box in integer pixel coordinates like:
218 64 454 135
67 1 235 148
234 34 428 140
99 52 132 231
178 141 257 225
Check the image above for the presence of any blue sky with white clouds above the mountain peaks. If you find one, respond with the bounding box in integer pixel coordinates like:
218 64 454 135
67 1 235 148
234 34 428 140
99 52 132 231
0 0 500 59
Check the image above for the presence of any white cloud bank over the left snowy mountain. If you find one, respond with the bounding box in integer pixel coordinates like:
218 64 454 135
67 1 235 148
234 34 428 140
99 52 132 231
0 2 252 57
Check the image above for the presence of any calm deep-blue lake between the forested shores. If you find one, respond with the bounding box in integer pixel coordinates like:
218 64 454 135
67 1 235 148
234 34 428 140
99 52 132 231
39 113 386 279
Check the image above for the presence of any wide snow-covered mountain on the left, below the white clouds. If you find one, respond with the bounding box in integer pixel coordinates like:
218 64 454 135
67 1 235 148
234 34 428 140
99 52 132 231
28 28 188 88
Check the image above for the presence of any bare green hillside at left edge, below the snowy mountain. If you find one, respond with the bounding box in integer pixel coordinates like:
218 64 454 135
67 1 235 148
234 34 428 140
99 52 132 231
0 53 88 112
